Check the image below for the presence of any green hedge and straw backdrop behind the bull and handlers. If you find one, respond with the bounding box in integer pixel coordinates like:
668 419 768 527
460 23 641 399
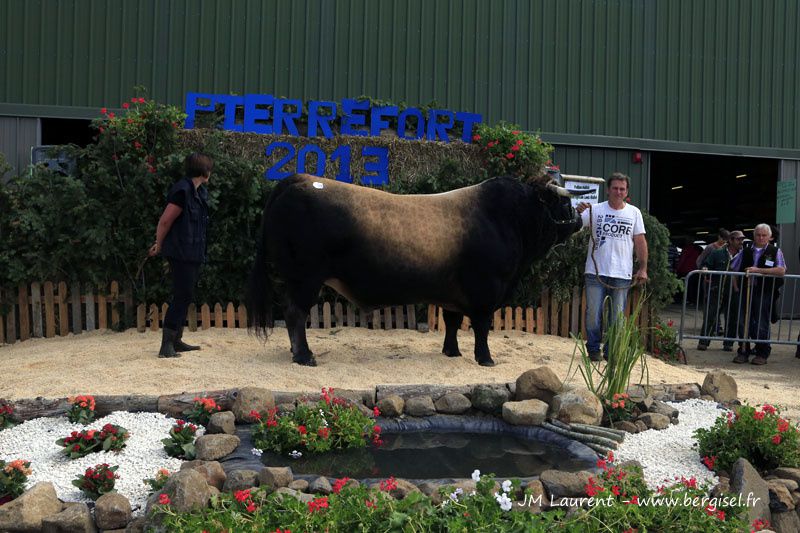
0 98 677 316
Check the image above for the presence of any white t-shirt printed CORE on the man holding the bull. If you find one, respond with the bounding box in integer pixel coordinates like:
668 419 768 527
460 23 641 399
581 202 645 279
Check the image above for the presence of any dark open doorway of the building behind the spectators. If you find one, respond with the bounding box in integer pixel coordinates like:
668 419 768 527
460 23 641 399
650 152 779 245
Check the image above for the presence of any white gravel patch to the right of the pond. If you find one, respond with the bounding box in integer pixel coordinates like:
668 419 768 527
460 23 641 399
614 399 725 489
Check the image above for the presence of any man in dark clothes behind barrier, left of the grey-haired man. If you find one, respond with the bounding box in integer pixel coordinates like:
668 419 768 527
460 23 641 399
697 231 744 352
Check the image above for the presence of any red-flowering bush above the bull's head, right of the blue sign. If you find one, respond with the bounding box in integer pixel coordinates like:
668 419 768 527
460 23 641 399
472 122 553 179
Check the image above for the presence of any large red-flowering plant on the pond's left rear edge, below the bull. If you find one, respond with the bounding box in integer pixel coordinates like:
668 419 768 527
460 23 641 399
253 388 382 457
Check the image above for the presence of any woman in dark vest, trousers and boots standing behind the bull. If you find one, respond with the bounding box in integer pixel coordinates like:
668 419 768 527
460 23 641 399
148 153 214 357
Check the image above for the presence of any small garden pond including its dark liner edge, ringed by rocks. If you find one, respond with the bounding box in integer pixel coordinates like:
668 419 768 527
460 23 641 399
222 415 597 480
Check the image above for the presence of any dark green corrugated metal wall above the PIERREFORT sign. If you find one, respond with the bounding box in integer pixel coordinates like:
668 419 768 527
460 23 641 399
0 0 800 149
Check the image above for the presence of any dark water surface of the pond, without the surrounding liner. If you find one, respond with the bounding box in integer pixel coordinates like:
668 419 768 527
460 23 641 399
262 429 594 479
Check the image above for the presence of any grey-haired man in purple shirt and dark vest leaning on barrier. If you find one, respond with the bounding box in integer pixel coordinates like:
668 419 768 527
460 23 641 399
731 224 786 365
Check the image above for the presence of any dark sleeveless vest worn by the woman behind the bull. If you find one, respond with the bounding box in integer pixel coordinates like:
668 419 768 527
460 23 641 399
161 177 208 263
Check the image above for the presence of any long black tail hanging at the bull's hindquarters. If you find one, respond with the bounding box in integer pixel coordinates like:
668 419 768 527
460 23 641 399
245 194 274 338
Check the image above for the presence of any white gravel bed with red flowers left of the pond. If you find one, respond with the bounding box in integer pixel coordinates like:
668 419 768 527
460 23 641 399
0 411 203 515
